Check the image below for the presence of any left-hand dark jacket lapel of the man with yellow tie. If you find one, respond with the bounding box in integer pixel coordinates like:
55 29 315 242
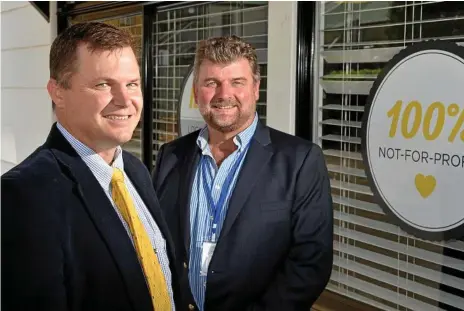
47 126 152 310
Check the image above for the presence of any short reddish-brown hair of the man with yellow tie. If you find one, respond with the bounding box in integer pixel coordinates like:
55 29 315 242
50 22 135 88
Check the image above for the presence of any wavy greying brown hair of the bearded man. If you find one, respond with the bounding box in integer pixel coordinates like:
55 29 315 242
193 36 260 82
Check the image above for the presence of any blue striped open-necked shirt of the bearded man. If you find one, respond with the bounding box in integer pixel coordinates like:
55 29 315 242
189 114 258 310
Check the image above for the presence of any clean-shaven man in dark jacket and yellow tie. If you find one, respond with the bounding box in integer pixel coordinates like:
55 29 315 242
1 22 178 311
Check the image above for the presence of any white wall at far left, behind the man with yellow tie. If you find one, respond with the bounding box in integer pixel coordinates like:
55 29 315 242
0 1 56 174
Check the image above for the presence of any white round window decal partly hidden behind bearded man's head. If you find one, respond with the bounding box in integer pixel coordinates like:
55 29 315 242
179 66 205 136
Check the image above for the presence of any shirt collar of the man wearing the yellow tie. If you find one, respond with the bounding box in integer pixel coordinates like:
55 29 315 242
57 122 124 191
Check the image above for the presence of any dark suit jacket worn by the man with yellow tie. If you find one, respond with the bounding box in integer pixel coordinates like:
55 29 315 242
1 125 178 311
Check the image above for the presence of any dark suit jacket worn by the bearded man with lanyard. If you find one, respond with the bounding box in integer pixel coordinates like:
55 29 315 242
153 123 333 311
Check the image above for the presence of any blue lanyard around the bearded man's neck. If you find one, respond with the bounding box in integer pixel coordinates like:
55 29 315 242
201 144 249 242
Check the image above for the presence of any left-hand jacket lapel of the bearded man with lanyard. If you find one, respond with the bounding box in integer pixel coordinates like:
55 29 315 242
179 143 200 256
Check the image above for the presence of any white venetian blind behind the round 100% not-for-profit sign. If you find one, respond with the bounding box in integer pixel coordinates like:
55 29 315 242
314 1 464 311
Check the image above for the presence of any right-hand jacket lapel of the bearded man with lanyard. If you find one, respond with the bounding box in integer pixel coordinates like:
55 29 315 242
219 123 273 239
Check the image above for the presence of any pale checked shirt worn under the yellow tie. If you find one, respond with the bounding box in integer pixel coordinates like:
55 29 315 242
57 122 175 311
